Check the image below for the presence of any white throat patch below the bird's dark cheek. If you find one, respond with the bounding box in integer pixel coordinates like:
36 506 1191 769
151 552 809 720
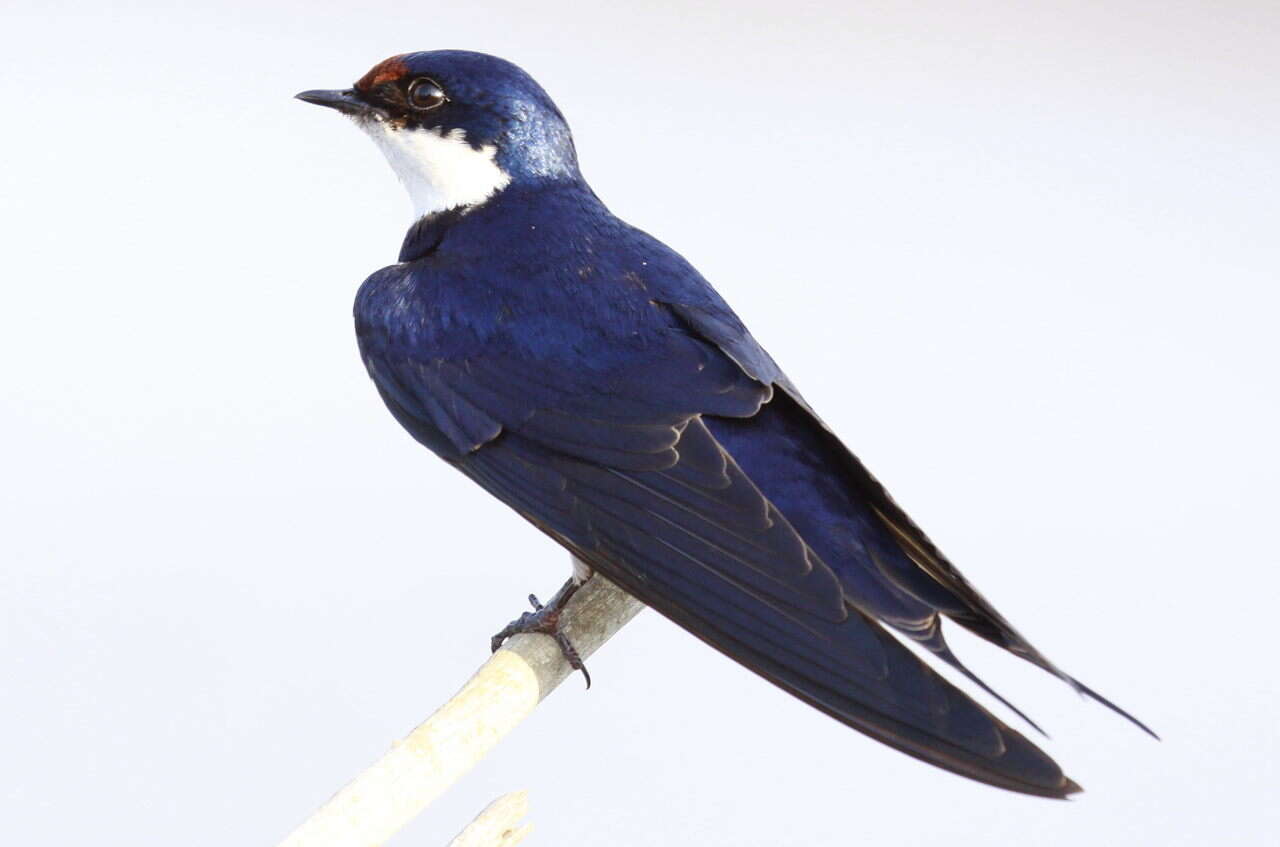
356 119 511 218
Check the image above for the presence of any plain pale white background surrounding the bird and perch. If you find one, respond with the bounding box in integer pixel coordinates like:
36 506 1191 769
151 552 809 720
0 0 1280 847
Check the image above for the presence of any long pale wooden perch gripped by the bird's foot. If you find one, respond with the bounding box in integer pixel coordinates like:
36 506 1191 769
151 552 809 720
280 574 644 847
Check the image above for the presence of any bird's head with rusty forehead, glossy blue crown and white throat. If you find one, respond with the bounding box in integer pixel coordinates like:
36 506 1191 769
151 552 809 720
297 50 579 218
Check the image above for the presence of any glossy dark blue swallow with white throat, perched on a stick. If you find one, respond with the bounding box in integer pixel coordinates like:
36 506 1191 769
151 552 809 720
298 50 1149 797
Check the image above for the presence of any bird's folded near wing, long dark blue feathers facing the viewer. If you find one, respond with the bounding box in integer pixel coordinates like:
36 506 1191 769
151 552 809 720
357 303 1078 797
